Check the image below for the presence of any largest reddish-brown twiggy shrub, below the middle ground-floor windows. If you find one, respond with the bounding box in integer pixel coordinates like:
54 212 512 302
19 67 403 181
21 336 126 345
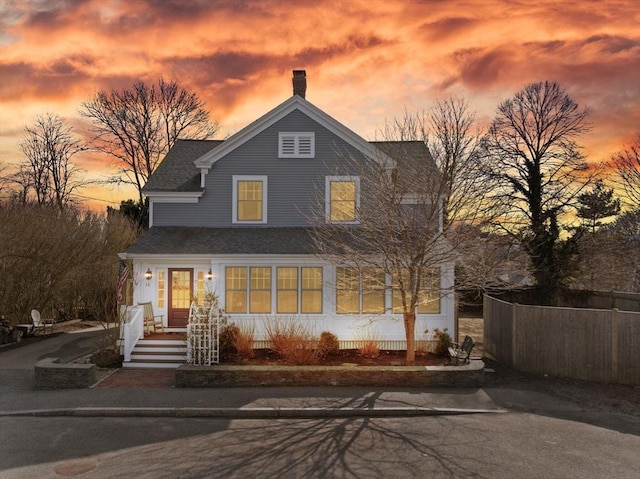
265 317 318 365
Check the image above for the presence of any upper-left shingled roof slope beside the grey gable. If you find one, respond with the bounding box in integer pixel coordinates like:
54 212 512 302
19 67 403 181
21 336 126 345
142 140 223 193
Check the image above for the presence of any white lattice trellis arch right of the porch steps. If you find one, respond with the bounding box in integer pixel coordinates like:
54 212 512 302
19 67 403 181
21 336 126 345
187 301 220 366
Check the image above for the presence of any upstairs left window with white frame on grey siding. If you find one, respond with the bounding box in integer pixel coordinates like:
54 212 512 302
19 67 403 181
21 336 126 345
233 176 267 223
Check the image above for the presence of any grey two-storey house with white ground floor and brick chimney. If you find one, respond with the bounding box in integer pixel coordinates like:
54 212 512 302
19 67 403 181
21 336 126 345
121 70 454 349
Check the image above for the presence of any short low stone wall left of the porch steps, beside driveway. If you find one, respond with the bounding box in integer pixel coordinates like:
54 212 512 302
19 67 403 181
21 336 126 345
34 358 97 389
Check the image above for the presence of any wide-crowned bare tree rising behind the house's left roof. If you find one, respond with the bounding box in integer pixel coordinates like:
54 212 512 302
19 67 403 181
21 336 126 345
80 78 218 204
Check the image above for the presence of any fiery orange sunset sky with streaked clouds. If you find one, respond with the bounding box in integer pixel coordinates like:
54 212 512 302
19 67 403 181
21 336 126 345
0 0 640 209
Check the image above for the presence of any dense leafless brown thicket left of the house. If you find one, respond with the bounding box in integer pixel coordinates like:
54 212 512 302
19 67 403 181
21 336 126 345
0 202 138 322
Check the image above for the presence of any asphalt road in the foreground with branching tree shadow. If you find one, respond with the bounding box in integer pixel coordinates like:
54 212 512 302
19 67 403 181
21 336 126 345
0 413 640 479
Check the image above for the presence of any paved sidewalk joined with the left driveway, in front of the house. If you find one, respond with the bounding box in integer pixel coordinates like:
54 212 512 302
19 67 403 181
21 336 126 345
0 327 503 418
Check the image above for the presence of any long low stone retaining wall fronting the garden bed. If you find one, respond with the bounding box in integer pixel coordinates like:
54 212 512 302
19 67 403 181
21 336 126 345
175 361 484 388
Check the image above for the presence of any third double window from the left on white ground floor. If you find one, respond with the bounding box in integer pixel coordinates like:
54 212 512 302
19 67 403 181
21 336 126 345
336 267 385 314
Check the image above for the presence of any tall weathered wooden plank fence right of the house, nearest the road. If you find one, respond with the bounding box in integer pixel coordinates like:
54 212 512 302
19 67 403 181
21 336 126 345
483 295 640 386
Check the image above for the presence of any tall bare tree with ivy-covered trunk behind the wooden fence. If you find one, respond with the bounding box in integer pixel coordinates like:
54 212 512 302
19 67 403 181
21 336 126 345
483 81 590 294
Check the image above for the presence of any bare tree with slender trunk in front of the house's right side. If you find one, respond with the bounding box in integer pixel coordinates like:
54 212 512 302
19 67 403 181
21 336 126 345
313 100 486 363
